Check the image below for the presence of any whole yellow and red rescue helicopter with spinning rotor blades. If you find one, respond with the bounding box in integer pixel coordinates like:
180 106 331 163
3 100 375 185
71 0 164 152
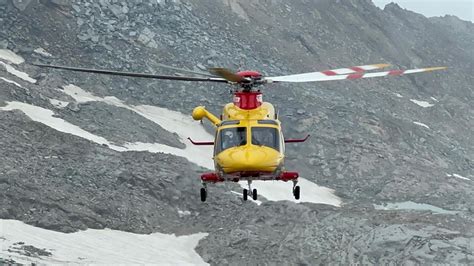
33 63 446 202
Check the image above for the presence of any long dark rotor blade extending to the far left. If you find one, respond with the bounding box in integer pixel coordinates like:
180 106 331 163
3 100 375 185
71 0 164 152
32 64 227 83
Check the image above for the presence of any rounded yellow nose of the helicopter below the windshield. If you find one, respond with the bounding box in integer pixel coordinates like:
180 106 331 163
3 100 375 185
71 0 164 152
216 145 283 173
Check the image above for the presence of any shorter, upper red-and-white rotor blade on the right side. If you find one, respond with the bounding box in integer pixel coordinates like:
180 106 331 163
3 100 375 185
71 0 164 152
267 64 390 82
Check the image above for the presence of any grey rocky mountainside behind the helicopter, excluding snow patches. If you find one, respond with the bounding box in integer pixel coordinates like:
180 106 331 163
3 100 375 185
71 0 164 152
0 0 474 264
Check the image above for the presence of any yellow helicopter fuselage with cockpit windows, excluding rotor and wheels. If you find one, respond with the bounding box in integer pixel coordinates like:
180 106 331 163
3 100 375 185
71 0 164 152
193 102 285 175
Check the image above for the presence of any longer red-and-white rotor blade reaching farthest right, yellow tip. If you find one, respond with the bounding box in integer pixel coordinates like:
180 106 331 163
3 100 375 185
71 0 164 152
266 67 446 83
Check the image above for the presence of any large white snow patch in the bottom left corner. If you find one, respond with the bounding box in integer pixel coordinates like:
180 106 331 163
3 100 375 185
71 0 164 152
0 220 208 265
